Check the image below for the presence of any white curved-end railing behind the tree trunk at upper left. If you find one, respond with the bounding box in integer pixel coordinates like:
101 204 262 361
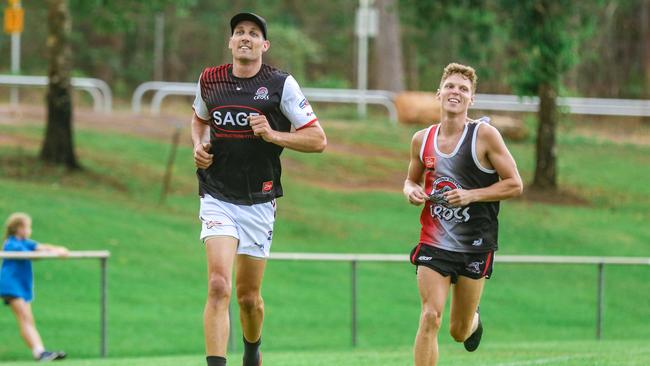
0 75 113 113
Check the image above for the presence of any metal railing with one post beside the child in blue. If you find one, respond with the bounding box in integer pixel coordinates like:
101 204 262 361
0 250 111 357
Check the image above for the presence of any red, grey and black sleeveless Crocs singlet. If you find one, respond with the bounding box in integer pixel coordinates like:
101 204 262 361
420 122 499 253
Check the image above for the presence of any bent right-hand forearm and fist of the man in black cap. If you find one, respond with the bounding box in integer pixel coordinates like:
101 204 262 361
250 115 327 152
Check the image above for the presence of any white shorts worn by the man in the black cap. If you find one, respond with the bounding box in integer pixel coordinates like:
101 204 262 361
199 194 276 259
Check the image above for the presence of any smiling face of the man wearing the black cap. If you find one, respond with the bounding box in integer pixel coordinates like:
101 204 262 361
228 20 270 61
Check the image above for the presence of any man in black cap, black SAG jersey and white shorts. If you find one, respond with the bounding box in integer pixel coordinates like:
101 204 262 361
192 13 327 366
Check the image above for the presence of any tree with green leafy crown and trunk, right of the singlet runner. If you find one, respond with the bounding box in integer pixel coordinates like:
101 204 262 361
503 0 589 190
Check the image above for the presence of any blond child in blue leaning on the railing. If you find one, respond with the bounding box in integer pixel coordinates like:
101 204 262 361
0 212 68 361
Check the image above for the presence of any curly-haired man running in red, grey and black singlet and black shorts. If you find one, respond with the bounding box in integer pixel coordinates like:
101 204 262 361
404 63 522 366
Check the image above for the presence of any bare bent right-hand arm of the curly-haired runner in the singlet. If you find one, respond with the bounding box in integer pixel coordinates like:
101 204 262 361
444 124 523 206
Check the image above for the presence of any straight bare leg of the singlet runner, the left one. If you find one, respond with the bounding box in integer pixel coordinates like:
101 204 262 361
414 266 451 366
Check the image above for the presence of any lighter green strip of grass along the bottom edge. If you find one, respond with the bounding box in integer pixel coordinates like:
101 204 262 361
3 341 650 366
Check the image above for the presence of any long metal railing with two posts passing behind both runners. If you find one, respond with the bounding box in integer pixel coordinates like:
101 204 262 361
270 253 650 346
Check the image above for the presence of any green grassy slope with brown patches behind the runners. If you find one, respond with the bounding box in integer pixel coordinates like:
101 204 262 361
0 114 650 366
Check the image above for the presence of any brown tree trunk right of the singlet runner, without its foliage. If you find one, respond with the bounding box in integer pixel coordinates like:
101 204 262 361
533 83 558 190
